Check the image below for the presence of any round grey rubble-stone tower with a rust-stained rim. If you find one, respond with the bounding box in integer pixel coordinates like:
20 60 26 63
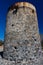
3 2 41 65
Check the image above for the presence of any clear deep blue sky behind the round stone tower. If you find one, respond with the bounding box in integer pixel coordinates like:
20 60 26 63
0 0 43 40
